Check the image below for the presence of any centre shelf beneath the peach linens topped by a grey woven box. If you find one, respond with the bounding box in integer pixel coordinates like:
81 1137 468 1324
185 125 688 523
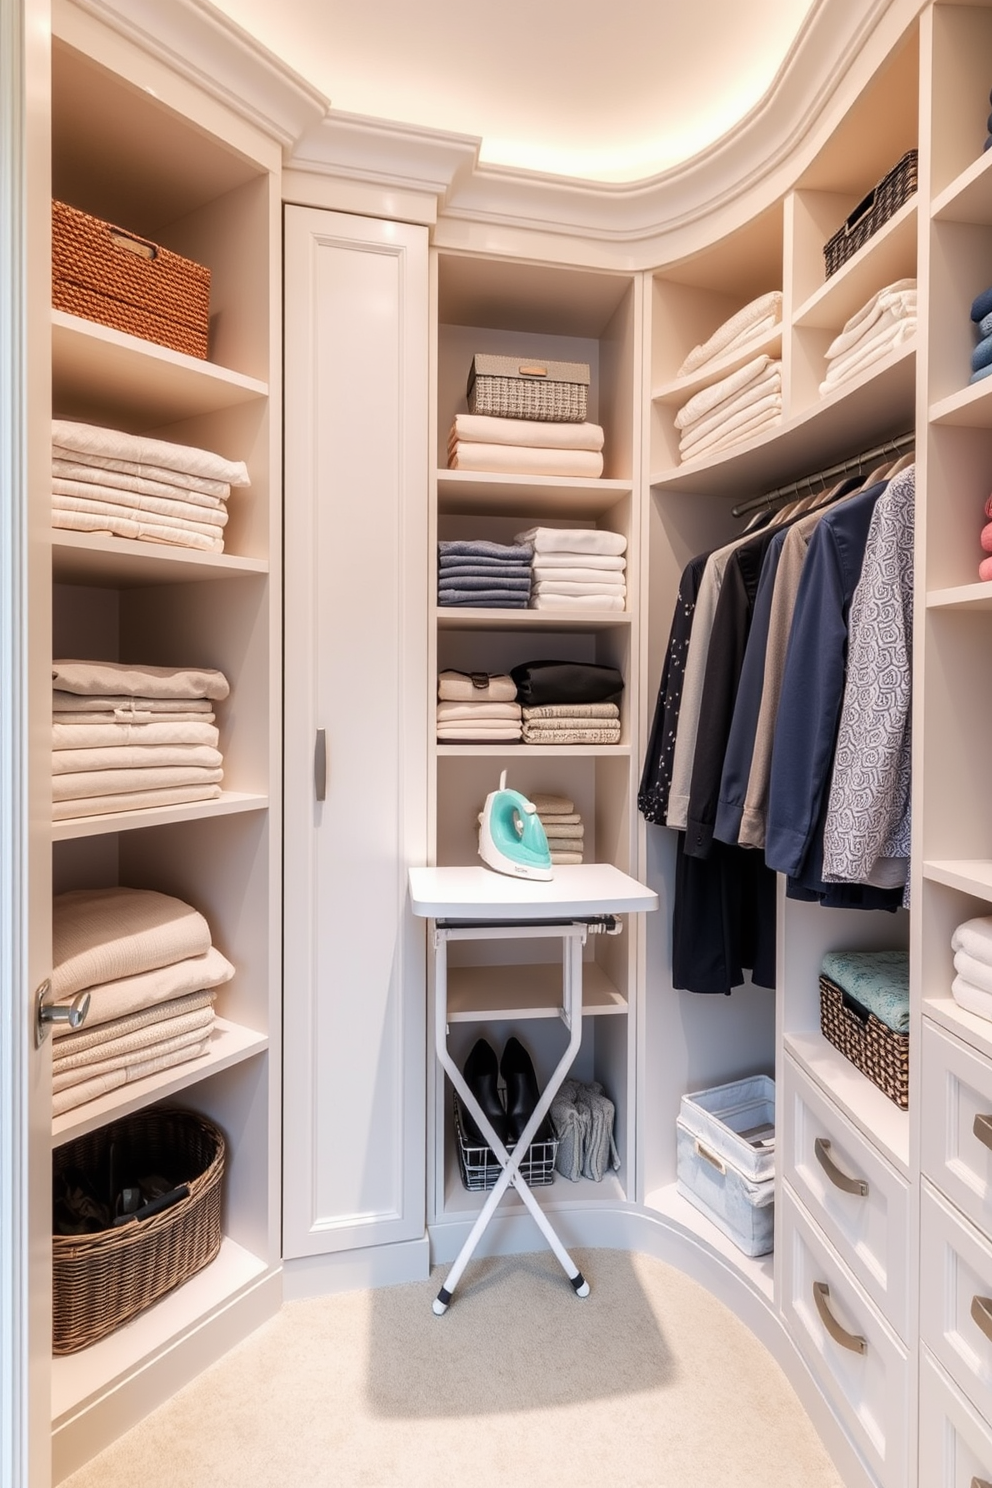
437 470 632 518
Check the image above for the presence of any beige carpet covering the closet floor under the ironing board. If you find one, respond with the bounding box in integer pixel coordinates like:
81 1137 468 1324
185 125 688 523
65 1250 840 1488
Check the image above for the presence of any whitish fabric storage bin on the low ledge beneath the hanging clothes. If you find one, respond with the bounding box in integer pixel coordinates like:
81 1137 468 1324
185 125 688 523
675 1074 775 1256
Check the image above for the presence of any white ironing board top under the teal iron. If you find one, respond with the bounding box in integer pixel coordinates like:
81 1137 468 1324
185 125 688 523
409 863 657 920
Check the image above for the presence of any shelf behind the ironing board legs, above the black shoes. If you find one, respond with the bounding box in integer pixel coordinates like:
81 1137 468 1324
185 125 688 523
448 961 628 1022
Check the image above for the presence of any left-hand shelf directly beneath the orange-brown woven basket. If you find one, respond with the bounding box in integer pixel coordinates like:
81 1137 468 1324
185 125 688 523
52 310 269 433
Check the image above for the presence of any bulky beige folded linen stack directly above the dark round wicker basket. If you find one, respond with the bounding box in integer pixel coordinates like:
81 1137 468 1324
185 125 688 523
52 888 233 1116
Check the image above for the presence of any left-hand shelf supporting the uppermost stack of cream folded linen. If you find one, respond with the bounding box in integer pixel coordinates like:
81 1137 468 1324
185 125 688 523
52 527 269 589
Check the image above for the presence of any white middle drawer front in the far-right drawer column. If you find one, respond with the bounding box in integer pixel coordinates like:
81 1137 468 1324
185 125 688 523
919 1183 992 1420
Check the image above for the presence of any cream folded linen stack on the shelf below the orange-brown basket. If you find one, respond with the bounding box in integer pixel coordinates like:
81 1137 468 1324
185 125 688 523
52 418 250 554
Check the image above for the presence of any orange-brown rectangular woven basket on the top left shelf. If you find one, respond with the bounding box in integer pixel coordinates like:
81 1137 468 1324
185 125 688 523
52 201 210 357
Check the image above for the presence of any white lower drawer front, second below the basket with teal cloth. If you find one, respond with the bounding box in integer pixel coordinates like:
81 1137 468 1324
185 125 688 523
779 1184 909 1488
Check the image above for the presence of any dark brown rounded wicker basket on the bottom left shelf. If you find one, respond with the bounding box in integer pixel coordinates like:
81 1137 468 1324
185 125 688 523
52 1107 225 1354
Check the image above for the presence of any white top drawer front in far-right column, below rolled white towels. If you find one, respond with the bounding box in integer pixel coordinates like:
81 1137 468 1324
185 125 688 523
921 1018 992 1234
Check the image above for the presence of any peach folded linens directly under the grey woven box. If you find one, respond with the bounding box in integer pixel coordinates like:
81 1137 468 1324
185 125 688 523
448 414 604 479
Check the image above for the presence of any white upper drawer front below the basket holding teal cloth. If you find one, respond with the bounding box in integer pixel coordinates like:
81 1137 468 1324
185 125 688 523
778 1058 909 1338
